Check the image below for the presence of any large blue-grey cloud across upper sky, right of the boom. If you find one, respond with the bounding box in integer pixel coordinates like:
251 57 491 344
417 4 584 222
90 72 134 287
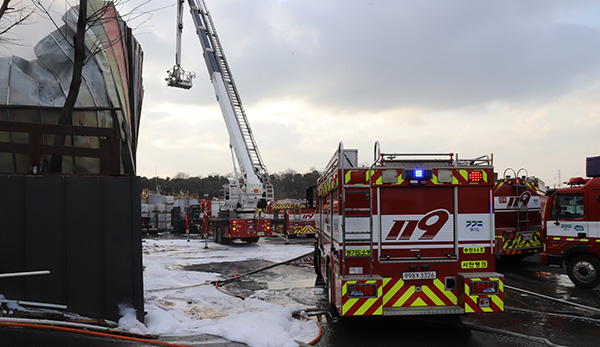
200 0 600 110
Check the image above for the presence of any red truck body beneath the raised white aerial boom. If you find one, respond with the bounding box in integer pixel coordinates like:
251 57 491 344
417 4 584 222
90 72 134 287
200 198 273 244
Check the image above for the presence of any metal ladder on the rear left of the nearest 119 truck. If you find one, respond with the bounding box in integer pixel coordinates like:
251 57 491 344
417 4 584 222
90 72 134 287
338 142 373 276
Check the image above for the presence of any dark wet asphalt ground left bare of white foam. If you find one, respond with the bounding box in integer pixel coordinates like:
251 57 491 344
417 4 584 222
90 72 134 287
0 234 600 347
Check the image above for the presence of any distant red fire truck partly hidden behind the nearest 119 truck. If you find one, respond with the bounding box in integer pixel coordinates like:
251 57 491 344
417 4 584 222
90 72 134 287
266 199 315 237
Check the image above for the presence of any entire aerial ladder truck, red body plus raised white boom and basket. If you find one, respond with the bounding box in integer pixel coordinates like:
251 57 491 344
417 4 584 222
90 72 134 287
166 0 274 243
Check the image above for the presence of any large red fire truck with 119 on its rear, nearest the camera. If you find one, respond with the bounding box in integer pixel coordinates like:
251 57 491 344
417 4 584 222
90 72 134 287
314 142 504 316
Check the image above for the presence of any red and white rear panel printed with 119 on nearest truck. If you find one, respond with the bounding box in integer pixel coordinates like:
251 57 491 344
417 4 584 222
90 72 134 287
373 186 457 261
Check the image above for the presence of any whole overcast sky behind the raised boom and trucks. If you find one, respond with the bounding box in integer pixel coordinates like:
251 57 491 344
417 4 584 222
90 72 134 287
4 0 600 186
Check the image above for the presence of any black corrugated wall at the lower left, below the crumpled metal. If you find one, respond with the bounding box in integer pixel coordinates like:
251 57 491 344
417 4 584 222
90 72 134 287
0 175 144 322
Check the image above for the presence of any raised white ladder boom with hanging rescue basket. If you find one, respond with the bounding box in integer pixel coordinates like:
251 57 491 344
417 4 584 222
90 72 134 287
167 0 273 206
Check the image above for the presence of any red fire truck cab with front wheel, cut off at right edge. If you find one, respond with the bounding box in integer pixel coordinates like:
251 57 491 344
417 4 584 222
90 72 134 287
540 156 600 288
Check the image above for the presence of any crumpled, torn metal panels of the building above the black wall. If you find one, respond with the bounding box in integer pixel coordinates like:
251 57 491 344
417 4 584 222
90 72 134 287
0 0 143 175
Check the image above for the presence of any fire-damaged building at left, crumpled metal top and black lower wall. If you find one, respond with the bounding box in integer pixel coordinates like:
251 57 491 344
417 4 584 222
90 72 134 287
0 0 143 320
